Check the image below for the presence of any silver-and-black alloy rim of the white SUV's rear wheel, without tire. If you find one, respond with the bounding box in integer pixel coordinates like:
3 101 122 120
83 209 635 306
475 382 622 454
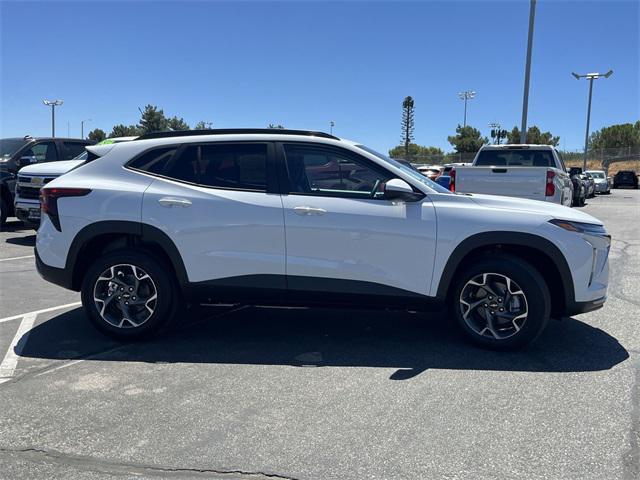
93 264 158 328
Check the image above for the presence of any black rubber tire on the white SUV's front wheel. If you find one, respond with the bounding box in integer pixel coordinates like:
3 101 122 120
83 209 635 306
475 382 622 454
450 254 551 350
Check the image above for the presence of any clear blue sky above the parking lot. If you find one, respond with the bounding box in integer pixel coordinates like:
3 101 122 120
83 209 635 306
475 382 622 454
0 0 640 150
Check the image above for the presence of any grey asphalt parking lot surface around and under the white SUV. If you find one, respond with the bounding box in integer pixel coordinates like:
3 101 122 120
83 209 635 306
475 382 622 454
0 190 640 480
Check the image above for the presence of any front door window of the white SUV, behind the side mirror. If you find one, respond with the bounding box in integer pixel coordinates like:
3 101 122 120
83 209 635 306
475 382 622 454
284 144 392 198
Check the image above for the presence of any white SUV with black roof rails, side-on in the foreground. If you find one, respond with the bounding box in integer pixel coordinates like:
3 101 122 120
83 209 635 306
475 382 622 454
36 129 611 349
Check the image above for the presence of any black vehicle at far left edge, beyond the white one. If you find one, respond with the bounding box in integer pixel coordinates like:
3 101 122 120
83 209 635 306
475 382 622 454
0 135 95 225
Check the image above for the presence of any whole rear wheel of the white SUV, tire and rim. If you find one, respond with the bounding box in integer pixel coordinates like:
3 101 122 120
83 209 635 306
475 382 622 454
82 249 178 340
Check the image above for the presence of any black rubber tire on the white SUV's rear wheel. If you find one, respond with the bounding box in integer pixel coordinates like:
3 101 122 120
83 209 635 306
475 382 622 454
81 249 180 341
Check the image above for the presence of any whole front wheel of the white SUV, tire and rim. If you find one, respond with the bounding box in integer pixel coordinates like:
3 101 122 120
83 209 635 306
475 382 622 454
451 255 551 350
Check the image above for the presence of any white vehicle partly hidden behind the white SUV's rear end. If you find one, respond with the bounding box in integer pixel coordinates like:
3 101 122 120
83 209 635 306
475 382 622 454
14 137 136 229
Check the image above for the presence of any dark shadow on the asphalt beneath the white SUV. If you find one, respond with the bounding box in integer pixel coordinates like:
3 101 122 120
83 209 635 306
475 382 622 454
20 307 629 380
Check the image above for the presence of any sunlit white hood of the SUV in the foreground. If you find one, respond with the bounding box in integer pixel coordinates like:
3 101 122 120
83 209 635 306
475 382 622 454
469 193 602 225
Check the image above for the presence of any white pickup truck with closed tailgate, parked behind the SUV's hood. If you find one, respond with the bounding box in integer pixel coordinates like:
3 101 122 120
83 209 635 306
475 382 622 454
450 145 572 207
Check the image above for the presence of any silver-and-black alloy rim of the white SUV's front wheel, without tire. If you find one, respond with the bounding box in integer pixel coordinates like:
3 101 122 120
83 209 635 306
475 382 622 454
459 273 529 340
